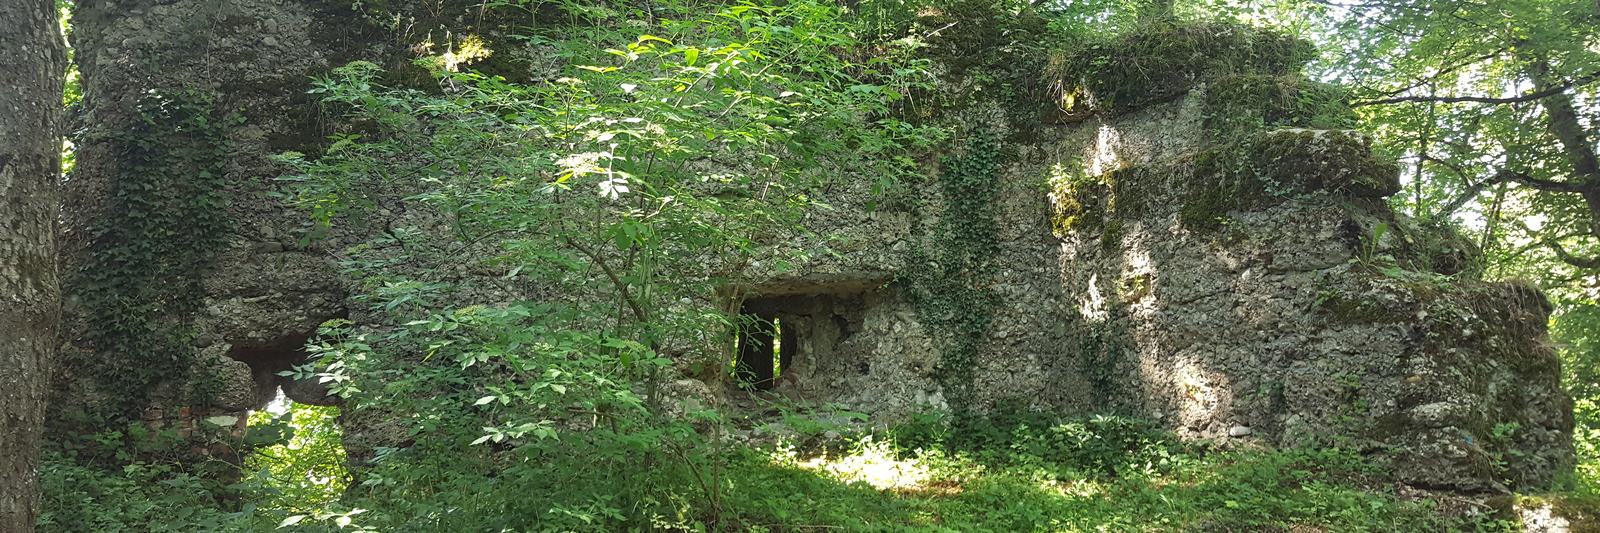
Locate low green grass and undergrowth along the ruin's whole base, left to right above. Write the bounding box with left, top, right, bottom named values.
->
left=40, top=407, right=1517, bottom=533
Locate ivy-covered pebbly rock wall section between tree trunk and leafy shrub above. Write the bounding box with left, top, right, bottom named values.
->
left=51, top=0, right=387, bottom=435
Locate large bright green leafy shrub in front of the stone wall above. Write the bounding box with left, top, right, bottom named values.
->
left=259, top=3, right=939, bottom=531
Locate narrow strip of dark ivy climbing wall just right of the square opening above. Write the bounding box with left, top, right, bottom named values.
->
left=898, top=133, right=1000, bottom=415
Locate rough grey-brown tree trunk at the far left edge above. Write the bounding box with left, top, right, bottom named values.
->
left=0, top=0, right=67, bottom=524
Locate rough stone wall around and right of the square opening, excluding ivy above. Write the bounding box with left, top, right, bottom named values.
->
left=736, top=88, right=1573, bottom=491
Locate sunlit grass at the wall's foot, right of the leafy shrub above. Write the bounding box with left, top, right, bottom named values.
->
left=697, top=409, right=1514, bottom=533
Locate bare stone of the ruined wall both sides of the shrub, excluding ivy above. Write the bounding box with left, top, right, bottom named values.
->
left=54, top=0, right=1573, bottom=491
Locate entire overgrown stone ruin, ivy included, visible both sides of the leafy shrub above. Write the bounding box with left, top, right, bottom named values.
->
left=54, top=0, right=1574, bottom=505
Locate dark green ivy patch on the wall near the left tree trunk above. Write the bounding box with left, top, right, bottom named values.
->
left=70, top=88, right=236, bottom=418
